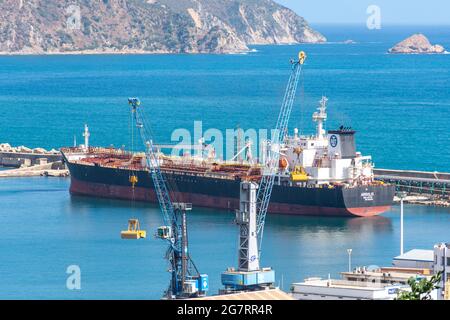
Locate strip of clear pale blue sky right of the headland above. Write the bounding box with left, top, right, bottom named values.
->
left=275, top=0, right=450, bottom=25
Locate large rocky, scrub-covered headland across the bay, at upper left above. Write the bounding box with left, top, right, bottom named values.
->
left=0, top=0, right=326, bottom=54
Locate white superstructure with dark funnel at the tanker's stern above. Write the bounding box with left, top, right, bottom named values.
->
left=280, top=97, right=374, bottom=186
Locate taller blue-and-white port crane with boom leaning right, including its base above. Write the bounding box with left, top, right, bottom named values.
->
left=221, top=51, right=306, bottom=293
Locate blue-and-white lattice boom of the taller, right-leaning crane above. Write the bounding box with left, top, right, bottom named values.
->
left=256, top=51, right=306, bottom=255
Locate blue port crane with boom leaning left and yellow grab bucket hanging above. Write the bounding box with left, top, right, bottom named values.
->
left=122, top=98, right=209, bottom=299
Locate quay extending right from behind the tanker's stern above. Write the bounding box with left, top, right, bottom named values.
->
left=374, top=169, right=450, bottom=207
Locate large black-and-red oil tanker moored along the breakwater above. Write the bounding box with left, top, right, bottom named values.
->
left=61, top=97, right=395, bottom=217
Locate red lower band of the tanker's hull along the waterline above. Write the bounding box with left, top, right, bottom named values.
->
left=70, top=177, right=390, bottom=217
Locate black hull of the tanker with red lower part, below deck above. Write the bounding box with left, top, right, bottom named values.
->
left=66, top=161, right=395, bottom=217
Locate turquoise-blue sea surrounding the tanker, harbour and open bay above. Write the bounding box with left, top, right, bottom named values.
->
left=0, top=25, right=450, bottom=299
